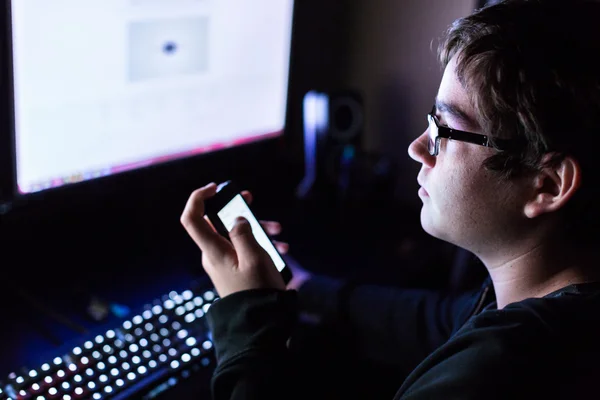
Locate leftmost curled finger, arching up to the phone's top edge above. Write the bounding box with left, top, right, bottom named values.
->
left=181, top=183, right=227, bottom=257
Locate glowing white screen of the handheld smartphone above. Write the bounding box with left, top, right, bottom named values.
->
left=217, top=194, right=285, bottom=272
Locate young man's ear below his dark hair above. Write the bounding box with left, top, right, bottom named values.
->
left=524, top=155, right=581, bottom=218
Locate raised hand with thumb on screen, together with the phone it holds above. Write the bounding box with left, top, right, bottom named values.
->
left=181, top=182, right=291, bottom=297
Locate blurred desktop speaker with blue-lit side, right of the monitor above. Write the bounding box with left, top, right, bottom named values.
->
left=297, top=90, right=365, bottom=198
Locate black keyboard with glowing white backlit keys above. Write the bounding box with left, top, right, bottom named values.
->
left=0, top=289, right=218, bottom=400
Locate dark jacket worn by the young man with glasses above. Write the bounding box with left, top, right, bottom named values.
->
left=207, top=280, right=600, bottom=400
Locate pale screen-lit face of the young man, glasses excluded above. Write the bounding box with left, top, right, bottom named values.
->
left=408, top=59, right=525, bottom=254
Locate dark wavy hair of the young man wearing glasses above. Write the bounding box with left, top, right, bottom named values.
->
left=438, top=0, right=600, bottom=245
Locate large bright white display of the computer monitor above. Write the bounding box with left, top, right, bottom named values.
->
left=12, top=0, right=293, bottom=193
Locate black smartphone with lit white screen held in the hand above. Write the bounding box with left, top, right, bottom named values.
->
left=205, top=181, right=292, bottom=284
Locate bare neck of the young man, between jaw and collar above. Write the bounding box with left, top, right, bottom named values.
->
left=480, top=241, right=600, bottom=309
